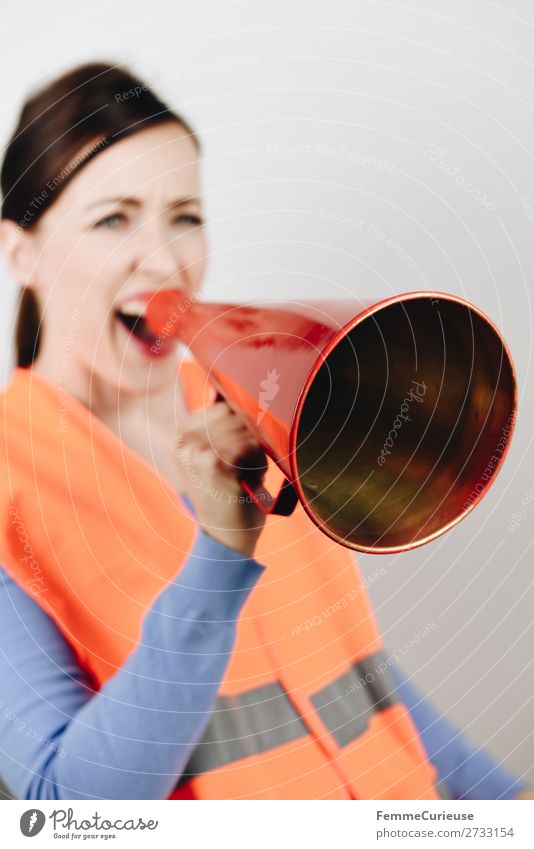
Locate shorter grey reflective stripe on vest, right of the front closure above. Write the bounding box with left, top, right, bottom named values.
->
left=311, top=652, right=398, bottom=746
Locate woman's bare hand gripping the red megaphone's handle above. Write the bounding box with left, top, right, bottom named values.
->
left=175, top=400, right=267, bottom=557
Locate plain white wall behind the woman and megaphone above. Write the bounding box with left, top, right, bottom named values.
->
left=0, top=0, right=534, bottom=781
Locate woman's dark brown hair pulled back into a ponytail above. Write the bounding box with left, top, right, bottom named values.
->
left=0, top=62, right=200, bottom=367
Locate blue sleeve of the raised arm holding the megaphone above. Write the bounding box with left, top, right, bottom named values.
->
left=0, top=529, right=265, bottom=799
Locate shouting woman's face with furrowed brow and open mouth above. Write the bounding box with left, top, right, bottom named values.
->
left=20, top=122, right=207, bottom=393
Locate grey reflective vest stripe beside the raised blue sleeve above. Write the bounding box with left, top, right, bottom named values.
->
left=176, top=681, right=308, bottom=787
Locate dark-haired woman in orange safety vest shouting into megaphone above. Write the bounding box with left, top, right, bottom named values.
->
left=0, top=64, right=521, bottom=799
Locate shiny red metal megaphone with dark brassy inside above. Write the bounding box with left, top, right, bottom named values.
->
left=145, top=290, right=517, bottom=553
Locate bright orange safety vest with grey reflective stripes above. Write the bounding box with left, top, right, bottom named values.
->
left=0, top=362, right=438, bottom=799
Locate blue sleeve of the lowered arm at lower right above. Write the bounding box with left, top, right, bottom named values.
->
left=390, top=666, right=526, bottom=799
